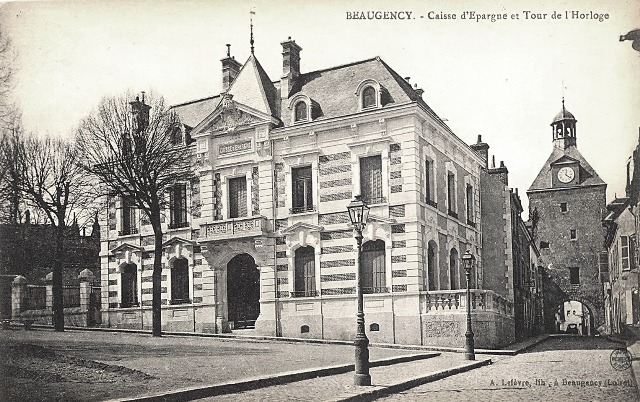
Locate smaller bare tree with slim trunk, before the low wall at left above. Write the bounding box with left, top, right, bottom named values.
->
left=10, top=133, right=93, bottom=331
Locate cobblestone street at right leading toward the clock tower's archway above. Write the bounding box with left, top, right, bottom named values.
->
left=381, top=337, right=638, bottom=402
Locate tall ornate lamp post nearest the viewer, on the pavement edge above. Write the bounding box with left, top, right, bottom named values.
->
left=347, top=195, right=371, bottom=385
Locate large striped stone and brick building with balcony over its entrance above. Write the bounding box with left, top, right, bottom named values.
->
left=102, top=39, right=513, bottom=347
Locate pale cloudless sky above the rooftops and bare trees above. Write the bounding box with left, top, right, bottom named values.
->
left=0, top=0, right=640, bottom=212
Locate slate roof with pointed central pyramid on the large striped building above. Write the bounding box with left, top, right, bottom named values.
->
left=172, top=55, right=430, bottom=128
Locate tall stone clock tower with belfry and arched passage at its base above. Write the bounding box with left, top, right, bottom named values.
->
left=527, top=99, right=607, bottom=334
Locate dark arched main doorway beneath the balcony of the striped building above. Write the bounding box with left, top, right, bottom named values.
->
left=227, top=254, right=260, bottom=328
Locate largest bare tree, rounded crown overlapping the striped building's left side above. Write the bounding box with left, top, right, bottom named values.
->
left=77, top=93, right=192, bottom=336
